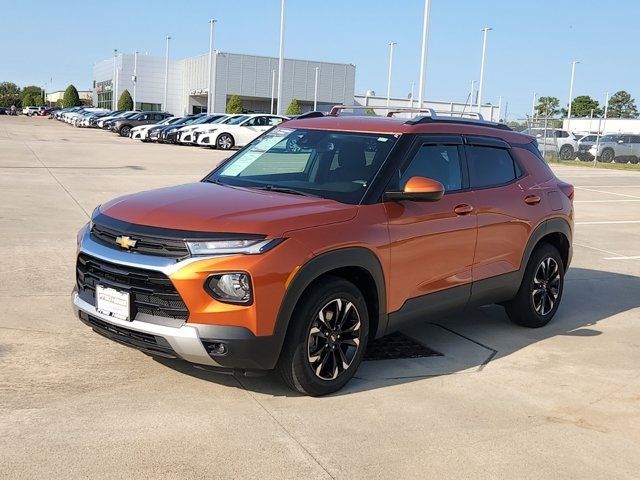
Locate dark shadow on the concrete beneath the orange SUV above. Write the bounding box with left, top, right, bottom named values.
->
left=156, top=268, right=640, bottom=396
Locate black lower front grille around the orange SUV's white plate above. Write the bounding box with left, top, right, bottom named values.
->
left=76, top=253, right=189, bottom=320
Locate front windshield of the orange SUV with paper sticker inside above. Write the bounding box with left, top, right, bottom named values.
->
left=205, top=128, right=396, bottom=204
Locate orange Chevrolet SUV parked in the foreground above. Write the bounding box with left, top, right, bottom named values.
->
left=72, top=107, right=573, bottom=395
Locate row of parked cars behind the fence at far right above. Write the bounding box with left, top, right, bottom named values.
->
left=522, top=128, right=640, bottom=164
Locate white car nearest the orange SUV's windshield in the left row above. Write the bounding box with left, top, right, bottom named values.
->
left=196, top=113, right=289, bottom=150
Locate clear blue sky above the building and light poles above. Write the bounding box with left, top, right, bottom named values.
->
left=0, top=0, right=640, bottom=119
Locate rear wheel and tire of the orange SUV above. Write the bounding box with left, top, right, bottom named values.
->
left=505, top=243, right=564, bottom=328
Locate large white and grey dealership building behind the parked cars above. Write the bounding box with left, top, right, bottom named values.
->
left=93, top=51, right=356, bottom=115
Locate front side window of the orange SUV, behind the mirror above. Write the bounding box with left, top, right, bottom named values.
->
left=399, top=144, right=462, bottom=192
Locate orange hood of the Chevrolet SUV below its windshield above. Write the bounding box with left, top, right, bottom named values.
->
left=99, top=182, right=358, bottom=238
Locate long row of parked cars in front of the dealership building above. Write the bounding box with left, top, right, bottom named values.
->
left=54, top=107, right=289, bottom=150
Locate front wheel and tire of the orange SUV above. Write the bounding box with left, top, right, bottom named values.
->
left=276, top=276, right=369, bottom=396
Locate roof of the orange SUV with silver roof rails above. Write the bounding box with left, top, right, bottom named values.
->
left=286, top=115, right=533, bottom=143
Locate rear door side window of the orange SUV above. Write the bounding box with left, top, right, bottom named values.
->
left=466, top=145, right=517, bottom=188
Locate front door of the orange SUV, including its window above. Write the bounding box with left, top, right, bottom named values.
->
left=385, top=135, right=477, bottom=326
